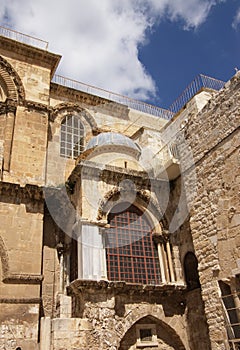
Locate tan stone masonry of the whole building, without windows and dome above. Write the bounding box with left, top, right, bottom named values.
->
left=0, top=33, right=240, bottom=350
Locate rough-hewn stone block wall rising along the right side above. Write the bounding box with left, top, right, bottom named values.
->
left=174, top=73, right=240, bottom=350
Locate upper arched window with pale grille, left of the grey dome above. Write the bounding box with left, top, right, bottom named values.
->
left=60, top=115, right=84, bottom=159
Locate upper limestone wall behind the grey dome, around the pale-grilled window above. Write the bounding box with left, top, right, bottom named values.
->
left=46, top=84, right=167, bottom=186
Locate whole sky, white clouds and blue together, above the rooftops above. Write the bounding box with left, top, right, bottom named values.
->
left=0, top=0, right=240, bottom=108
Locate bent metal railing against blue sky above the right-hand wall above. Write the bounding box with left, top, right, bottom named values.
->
left=169, top=74, right=225, bottom=114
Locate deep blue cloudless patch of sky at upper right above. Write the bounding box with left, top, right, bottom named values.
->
left=139, top=1, right=240, bottom=107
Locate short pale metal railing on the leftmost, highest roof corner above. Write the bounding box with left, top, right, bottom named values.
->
left=0, top=26, right=48, bottom=50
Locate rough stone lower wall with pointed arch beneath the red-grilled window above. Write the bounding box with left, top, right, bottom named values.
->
left=46, top=281, right=188, bottom=350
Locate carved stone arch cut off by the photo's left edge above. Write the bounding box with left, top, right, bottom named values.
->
left=0, top=56, right=25, bottom=104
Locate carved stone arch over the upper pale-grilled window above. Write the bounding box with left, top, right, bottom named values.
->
left=51, top=103, right=98, bottom=134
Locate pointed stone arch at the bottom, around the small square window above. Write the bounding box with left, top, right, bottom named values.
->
left=118, top=314, right=186, bottom=350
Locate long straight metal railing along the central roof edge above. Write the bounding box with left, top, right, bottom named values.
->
left=52, top=74, right=173, bottom=120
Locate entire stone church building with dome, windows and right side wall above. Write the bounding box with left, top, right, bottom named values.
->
left=0, top=29, right=240, bottom=350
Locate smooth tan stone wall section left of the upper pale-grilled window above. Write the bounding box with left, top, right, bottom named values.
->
left=3, top=107, right=48, bottom=185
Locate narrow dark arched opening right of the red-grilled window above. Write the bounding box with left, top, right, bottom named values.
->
left=184, top=252, right=200, bottom=289
